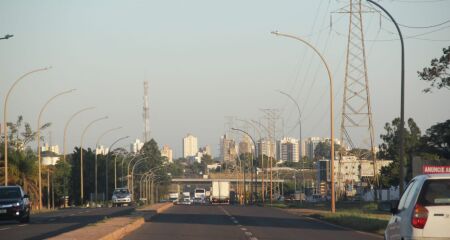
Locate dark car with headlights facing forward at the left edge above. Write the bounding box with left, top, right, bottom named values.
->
left=0, top=186, right=30, bottom=223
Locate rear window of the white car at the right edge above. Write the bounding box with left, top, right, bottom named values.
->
left=419, top=179, right=450, bottom=206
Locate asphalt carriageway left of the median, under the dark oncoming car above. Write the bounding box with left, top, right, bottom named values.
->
left=0, top=207, right=133, bottom=240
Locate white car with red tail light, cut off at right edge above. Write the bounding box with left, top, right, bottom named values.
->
left=384, top=174, right=450, bottom=240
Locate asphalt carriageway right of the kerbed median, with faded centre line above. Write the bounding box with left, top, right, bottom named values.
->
left=125, top=205, right=382, bottom=240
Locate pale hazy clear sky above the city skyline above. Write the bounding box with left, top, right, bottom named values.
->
left=0, top=0, right=450, bottom=157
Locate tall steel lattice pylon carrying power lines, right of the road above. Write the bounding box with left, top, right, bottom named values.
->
left=340, top=0, right=376, bottom=163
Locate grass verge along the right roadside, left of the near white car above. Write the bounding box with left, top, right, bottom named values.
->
left=271, top=201, right=391, bottom=234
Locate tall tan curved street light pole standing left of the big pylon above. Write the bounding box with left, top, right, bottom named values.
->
left=272, top=31, right=336, bottom=213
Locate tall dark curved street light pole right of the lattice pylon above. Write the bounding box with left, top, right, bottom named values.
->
left=367, top=0, right=405, bottom=195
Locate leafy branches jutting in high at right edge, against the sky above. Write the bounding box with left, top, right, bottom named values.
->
left=417, top=46, right=450, bottom=93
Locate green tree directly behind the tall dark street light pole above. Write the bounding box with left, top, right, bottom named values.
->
left=378, top=118, right=421, bottom=187
